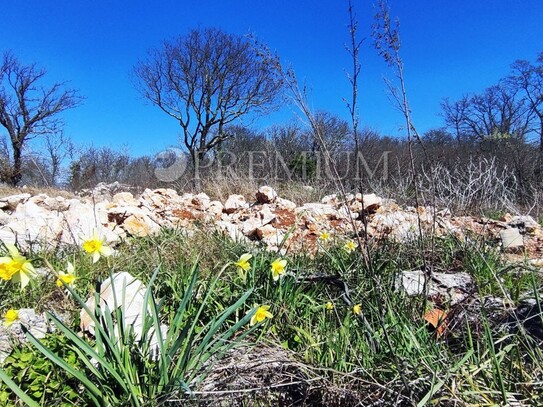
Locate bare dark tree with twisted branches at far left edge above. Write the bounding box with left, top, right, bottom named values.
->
left=0, top=52, right=81, bottom=186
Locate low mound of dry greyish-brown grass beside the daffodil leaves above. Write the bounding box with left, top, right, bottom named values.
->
left=177, top=343, right=379, bottom=407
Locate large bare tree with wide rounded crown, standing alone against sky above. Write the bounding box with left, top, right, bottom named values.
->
left=134, top=28, right=282, bottom=183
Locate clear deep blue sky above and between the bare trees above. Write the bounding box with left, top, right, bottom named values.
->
left=0, top=0, right=543, bottom=155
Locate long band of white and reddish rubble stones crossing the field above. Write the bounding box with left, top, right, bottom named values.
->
left=0, top=185, right=543, bottom=265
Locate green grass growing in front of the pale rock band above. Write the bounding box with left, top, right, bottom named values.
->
left=0, top=230, right=543, bottom=406
